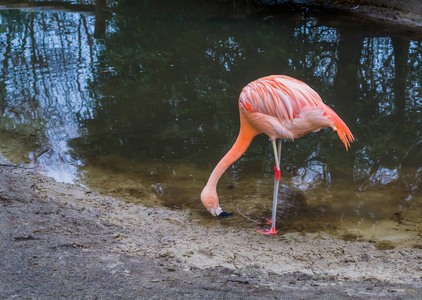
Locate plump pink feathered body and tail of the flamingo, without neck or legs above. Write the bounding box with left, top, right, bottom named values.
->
left=239, top=75, right=354, bottom=149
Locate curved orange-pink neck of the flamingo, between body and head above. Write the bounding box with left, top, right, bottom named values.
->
left=205, top=122, right=259, bottom=190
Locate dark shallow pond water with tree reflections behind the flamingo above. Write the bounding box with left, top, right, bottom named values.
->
left=0, top=1, right=422, bottom=249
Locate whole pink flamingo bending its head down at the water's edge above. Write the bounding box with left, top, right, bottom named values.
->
left=201, top=75, right=354, bottom=234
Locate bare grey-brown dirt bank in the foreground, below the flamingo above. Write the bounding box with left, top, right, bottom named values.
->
left=0, top=166, right=422, bottom=299
